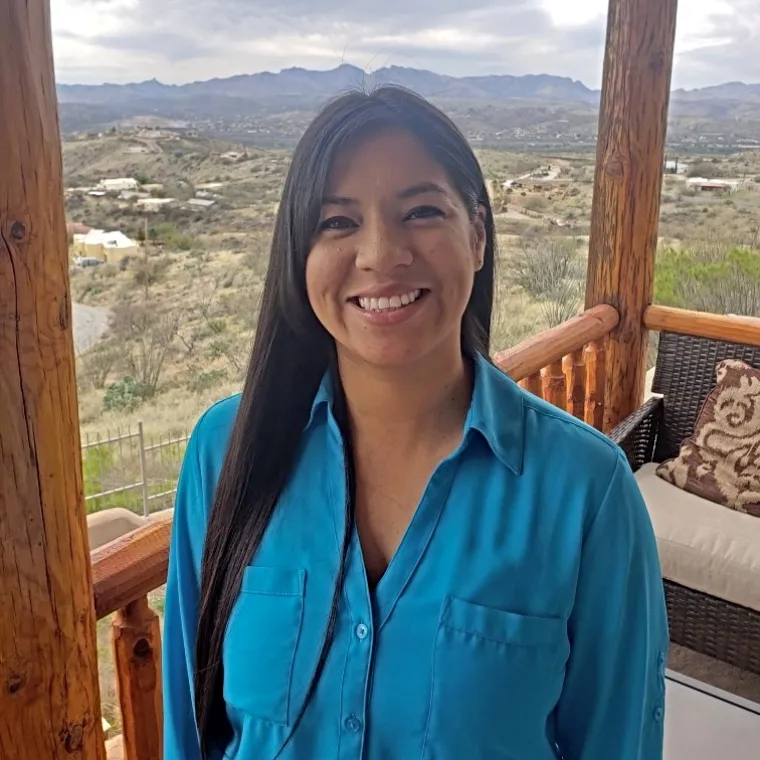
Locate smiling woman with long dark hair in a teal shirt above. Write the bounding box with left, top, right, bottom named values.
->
left=164, top=87, right=668, bottom=760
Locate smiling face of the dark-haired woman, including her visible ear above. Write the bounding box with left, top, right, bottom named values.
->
left=306, top=130, right=485, bottom=367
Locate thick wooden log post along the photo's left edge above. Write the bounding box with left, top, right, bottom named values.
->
left=0, top=0, right=105, bottom=760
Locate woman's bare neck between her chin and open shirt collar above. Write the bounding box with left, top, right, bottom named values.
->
left=338, top=346, right=473, bottom=450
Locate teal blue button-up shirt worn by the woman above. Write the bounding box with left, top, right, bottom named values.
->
left=163, top=358, right=668, bottom=760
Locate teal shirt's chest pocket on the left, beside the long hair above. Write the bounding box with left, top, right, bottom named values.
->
left=222, top=566, right=306, bottom=726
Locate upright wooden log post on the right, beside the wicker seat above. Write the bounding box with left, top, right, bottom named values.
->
left=586, top=0, right=678, bottom=431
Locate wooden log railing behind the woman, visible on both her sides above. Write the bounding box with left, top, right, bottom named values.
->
left=91, top=306, right=618, bottom=760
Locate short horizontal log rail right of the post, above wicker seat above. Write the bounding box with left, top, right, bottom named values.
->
left=644, top=306, right=760, bottom=346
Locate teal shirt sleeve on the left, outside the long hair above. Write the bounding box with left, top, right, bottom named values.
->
left=163, top=428, right=206, bottom=760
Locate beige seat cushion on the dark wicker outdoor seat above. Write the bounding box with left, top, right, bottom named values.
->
left=636, top=464, right=760, bottom=612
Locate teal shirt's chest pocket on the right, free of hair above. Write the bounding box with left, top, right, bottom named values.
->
left=423, top=597, right=569, bottom=760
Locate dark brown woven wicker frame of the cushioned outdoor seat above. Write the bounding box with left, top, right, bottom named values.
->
left=610, top=332, right=760, bottom=673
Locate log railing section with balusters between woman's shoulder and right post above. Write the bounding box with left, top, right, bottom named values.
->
left=494, top=305, right=619, bottom=430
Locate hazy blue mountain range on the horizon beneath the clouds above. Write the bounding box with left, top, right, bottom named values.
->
left=58, top=64, right=760, bottom=148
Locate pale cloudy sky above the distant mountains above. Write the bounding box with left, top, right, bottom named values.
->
left=51, top=0, right=760, bottom=88
